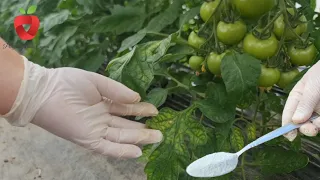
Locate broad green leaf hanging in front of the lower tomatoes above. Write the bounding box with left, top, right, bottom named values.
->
left=221, top=52, right=261, bottom=101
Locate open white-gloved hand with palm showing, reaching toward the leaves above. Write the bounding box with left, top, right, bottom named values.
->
left=3, top=57, right=162, bottom=158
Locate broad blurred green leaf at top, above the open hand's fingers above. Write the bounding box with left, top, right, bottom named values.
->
left=91, top=5, right=146, bottom=35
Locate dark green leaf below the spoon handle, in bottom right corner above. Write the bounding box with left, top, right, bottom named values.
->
left=256, top=147, right=309, bottom=175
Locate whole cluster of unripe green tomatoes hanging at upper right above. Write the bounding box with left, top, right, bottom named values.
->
left=188, top=0, right=318, bottom=88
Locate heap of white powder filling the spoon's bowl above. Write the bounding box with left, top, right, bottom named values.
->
left=187, top=152, right=238, bottom=177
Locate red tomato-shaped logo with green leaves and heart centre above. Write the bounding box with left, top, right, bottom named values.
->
left=14, top=6, right=40, bottom=40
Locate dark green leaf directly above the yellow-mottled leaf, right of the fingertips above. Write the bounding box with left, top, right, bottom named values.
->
left=196, top=83, right=236, bottom=123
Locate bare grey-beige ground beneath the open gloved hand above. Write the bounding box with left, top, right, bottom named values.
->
left=0, top=119, right=146, bottom=180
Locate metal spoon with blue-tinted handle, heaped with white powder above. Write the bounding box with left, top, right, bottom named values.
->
left=186, top=113, right=319, bottom=177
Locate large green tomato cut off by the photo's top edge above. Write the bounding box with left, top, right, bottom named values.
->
left=232, top=0, right=277, bottom=19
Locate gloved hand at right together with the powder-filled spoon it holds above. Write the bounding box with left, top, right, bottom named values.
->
left=186, top=62, right=320, bottom=177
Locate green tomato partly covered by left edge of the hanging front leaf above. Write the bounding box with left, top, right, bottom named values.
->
left=207, top=51, right=227, bottom=75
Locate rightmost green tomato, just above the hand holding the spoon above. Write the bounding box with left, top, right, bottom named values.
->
left=288, top=44, right=317, bottom=66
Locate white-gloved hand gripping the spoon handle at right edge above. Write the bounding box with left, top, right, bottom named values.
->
left=282, top=62, right=320, bottom=141
